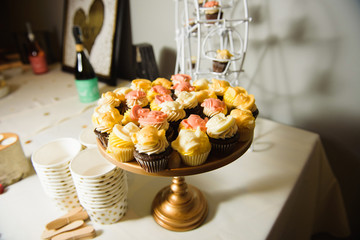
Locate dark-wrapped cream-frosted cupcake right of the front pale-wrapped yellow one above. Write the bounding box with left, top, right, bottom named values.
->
left=206, top=113, right=239, bottom=154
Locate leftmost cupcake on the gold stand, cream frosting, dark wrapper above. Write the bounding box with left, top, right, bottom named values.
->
left=91, top=105, right=123, bottom=148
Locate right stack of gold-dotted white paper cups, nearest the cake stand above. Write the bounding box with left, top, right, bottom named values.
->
left=70, top=148, right=128, bottom=224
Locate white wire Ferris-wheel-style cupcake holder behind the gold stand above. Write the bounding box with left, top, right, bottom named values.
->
left=175, top=0, right=251, bottom=85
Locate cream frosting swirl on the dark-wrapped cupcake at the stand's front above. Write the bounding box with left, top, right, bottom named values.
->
left=131, top=126, right=169, bottom=155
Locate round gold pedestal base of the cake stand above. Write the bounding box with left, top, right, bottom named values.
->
left=152, top=177, right=208, bottom=232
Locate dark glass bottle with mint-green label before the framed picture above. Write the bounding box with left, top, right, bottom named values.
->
left=73, top=26, right=100, bottom=103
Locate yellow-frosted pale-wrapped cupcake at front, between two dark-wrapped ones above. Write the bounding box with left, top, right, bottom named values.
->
left=171, top=127, right=211, bottom=166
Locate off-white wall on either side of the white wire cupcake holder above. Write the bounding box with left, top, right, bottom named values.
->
left=130, top=0, right=360, bottom=236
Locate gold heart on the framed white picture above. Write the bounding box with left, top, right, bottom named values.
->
left=73, top=0, right=104, bottom=54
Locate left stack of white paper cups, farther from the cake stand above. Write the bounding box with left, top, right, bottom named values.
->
left=31, top=138, right=81, bottom=211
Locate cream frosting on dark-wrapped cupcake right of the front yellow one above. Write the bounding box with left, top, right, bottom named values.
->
left=206, top=113, right=238, bottom=139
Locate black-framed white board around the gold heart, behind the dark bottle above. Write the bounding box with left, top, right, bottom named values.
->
left=61, top=0, right=125, bottom=86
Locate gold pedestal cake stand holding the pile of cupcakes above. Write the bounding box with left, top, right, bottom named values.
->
left=97, top=138, right=252, bottom=231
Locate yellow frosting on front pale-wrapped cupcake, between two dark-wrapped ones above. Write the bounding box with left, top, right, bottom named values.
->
left=171, top=127, right=211, bottom=156
